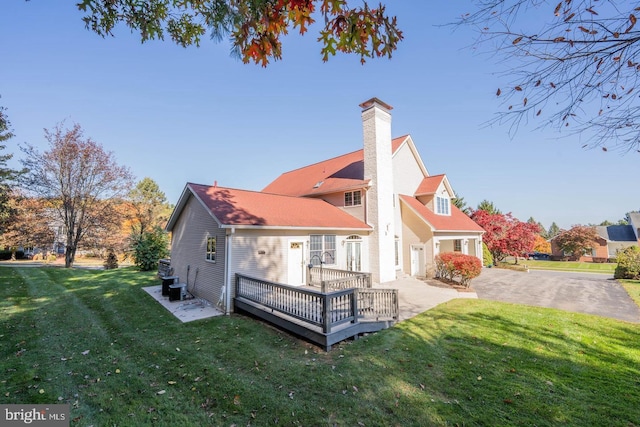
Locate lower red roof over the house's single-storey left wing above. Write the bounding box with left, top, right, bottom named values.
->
left=167, top=183, right=371, bottom=230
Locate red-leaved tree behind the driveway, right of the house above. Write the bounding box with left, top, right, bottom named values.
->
left=471, top=209, right=540, bottom=263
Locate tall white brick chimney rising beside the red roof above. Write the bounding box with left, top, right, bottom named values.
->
left=360, top=98, right=396, bottom=283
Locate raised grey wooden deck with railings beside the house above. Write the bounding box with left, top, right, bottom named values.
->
left=234, top=274, right=399, bottom=351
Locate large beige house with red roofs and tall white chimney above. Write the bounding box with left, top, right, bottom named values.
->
left=167, top=98, right=484, bottom=311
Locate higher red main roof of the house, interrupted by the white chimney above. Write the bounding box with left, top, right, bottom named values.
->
left=262, top=135, right=408, bottom=196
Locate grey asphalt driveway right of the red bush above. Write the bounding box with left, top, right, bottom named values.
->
left=471, top=268, right=640, bottom=323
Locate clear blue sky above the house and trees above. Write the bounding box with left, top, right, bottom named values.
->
left=0, top=0, right=640, bottom=228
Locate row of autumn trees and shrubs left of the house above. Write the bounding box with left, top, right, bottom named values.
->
left=0, top=108, right=172, bottom=270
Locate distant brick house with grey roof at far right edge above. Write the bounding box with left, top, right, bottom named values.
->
left=551, top=212, right=640, bottom=262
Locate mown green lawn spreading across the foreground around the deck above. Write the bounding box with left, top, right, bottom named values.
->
left=0, top=267, right=640, bottom=427
